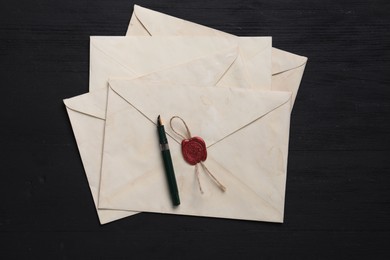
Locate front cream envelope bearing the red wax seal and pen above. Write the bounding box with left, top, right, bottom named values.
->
left=99, top=80, right=291, bottom=222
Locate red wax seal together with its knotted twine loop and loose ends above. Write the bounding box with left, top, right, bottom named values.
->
left=169, top=116, right=226, bottom=194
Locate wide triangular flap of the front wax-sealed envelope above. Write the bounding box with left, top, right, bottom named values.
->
left=110, top=80, right=291, bottom=146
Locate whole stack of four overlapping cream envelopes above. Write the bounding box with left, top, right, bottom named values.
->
left=64, top=6, right=307, bottom=224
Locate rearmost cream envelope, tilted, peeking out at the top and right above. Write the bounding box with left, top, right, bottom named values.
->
left=127, top=5, right=307, bottom=106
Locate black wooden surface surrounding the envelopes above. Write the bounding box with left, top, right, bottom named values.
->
left=0, top=0, right=390, bottom=259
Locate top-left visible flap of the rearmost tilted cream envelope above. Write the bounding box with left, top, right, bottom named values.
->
left=134, top=5, right=232, bottom=37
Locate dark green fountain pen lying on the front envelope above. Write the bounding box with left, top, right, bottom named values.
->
left=157, top=116, right=180, bottom=206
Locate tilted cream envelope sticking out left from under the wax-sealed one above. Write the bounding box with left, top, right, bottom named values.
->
left=64, top=37, right=271, bottom=224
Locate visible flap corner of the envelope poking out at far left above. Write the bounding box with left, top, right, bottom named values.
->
left=64, top=88, right=107, bottom=119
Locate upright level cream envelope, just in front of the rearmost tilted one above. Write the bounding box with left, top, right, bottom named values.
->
left=89, top=36, right=272, bottom=91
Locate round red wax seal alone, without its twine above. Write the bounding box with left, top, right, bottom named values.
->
left=181, top=136, right=207, bottom=165
